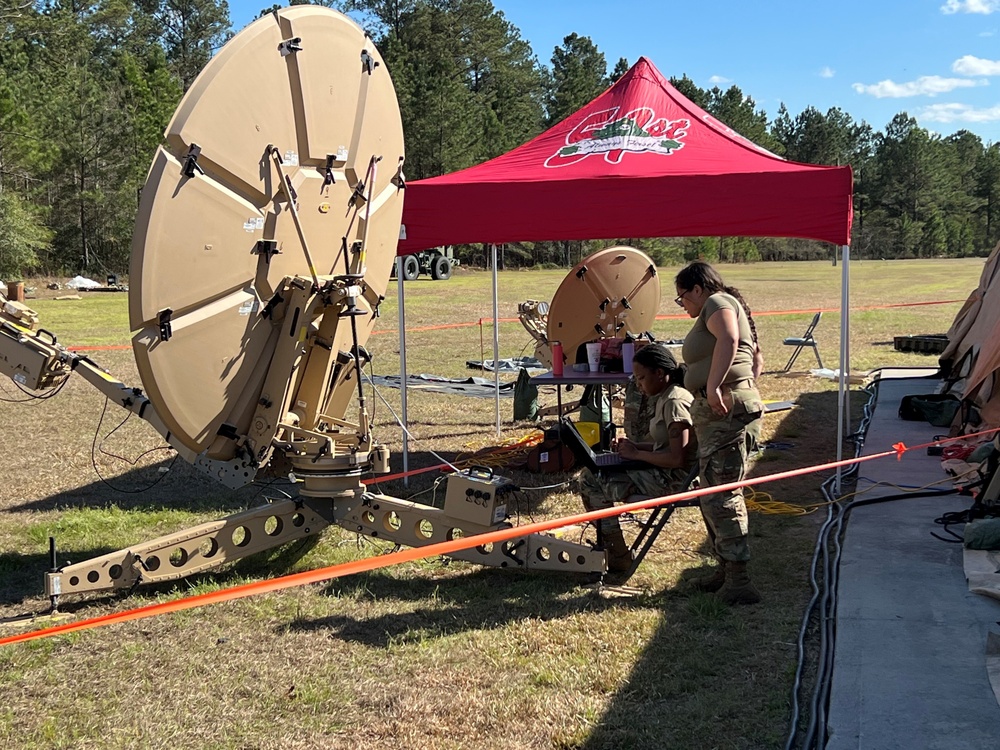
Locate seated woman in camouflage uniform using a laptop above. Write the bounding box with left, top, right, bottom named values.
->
left=581, top=344, right=698, bottom=573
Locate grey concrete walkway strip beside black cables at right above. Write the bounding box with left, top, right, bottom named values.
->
left=826, top=370, right=1000, bottom=750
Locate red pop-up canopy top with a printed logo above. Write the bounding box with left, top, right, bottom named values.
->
left=398, top=57, right=853, bottom=255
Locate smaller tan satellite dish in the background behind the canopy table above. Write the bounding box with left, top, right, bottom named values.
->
left=546, top=246, right=660, bottom=364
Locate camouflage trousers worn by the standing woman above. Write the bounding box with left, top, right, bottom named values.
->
left=691, top=388, right=764, bottom=562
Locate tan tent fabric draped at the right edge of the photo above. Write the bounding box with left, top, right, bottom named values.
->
left=941, top=244, right=1000, bottom=428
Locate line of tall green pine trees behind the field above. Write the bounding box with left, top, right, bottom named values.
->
left=0, top=0, right=1000, bottom=278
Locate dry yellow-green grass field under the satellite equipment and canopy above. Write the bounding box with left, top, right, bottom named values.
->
left=0, top=259, right=983, bottom=750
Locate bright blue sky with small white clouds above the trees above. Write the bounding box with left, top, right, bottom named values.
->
left=229, top=0, right=1000, bottom=143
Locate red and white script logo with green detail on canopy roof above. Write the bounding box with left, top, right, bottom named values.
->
left=545, top=107, right=691, bottom=167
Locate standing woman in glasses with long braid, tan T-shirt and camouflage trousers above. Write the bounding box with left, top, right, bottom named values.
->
left=674, top=261, right=764, bottom=604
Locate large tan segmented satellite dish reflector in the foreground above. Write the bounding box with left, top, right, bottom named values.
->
left=129, top=5, right=403, bottom=460
